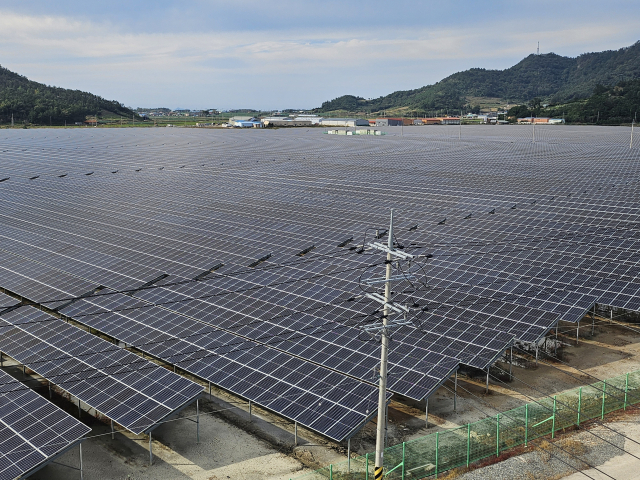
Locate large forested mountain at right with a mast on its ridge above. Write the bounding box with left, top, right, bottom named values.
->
left=316, top=42, right=640, bottom=112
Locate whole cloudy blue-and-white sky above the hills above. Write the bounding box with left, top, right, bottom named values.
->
left=0, top=0, right=640, bottom=109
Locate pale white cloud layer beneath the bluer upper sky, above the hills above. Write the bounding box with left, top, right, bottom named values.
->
left=0, top=10, right=637, bottom=108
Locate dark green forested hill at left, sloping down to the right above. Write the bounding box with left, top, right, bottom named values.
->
left=0, top=66, right=137, bottom=125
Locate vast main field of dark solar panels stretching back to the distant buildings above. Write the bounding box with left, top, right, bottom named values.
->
left=0, top=126, right=640, bottom=439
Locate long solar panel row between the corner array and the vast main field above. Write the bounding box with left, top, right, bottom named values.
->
left=0, top=306, right=202, bottom=434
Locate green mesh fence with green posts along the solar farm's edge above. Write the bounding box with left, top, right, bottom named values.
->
left=296, top=371, right=640, bottom=480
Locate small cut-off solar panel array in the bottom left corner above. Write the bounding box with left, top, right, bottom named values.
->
left=0, top=370, right=91, bottom=480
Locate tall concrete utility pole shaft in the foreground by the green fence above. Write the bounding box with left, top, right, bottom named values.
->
left=374, top=209, right=393, bottom=480
